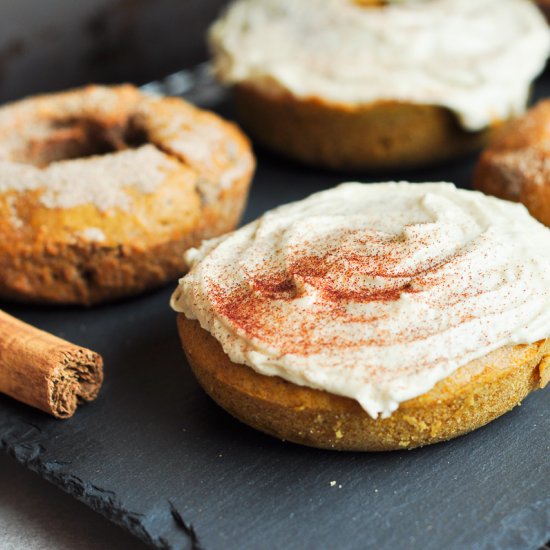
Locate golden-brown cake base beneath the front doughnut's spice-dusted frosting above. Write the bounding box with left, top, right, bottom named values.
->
left=178, top=314, right=550, bottom=451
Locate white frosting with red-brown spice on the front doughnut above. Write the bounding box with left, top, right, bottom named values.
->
left=171, top=182, right=550, bottom=417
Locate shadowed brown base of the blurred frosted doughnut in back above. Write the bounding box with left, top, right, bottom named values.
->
left=234, top=85, right=489, bottom=171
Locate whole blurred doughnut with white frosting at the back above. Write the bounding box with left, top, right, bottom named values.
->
left=210, top=0, right=550, bottom=170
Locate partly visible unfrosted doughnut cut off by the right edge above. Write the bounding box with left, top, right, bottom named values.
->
left=474, top=100, right=550, bottom=226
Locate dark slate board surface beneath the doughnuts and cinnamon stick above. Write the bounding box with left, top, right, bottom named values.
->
left=0, top=76, right=550, bottom=550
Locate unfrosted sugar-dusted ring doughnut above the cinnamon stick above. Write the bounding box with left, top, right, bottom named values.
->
left=0, top=85, right=254, bottom=304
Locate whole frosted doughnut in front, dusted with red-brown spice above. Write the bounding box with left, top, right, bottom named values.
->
left=172, top=183, right=550, bottom=451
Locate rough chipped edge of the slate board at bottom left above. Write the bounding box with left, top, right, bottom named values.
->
left=0, top=421, right=195, bottom=550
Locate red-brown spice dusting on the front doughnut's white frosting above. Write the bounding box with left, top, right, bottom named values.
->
left=210, top=225, right=494, bottom=362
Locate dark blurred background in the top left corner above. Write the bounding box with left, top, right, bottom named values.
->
left=0, top=0, right=226, bottom=102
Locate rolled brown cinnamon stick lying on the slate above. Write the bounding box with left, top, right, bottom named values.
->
left=0, top=311, right=103, bottom=418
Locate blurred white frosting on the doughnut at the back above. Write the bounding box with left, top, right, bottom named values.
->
left=210, top=0, right=550, bottom=130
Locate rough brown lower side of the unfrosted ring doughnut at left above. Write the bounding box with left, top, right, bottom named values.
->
left=0, top=184, right=250, bottom=305
